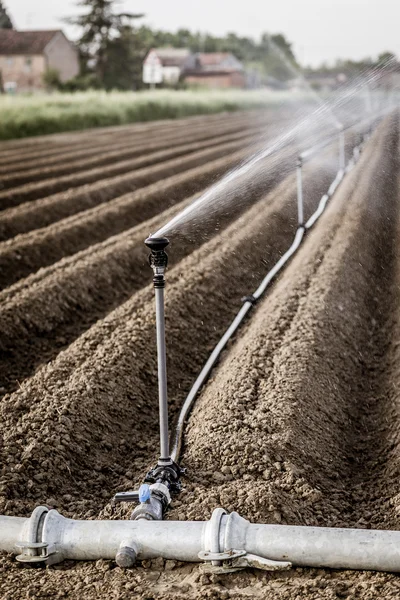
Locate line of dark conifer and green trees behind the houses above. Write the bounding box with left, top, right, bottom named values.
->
left=61, top=0, right=297, bottom=90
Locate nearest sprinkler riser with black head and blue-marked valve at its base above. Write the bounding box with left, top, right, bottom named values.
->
left=114, top=237, right=183, bottom=520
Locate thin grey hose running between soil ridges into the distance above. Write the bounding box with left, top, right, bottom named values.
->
left=171, top=123, right=376, bottom=462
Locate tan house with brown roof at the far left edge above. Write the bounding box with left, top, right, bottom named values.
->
left=0, top=29, right=79, bottom=92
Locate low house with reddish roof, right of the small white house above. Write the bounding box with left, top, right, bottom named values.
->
left=184, top=52, right=247, bottom=88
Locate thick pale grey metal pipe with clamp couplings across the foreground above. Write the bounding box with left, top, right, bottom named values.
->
left=5, top=506, right=400, bottom=573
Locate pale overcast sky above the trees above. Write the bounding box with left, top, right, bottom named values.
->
left=7, top=0, right=400, bottom=65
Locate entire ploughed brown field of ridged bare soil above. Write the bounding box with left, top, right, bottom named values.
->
left=0, top=110, right=400, bottom=600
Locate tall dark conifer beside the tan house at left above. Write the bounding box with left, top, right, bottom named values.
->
left=66, top=0, right=143, bottom=83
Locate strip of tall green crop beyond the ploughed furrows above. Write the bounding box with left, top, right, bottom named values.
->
left=0, top=90, right=298, bottom=140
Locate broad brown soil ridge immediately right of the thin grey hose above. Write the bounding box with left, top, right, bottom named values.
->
left=180, top=113, right=398, bottom=526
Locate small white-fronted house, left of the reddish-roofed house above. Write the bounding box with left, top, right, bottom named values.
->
left=143, top=48, right=191, bottom=85
